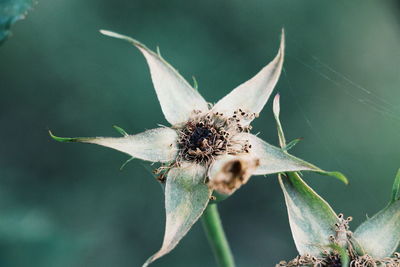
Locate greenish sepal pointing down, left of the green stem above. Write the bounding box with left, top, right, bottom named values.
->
left=143, top=163, right=211, bottom=266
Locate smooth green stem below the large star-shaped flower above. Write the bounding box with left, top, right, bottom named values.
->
left=201, top=204, right=235, bottom=267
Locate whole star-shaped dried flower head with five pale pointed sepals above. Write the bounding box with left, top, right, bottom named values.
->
left=52, top=30, right=345, bottom=266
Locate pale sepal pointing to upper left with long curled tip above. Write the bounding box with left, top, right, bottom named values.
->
left=100, top=30, right=208, bottom=125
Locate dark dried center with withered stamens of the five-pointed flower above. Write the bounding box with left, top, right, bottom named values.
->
left=177, top=112, right=250, bottom=165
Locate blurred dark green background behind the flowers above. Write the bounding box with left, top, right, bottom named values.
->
left=0, top=0, right=400, bottom=267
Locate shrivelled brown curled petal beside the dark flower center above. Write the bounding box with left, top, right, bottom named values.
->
left=208, top=154, right=259, bottom=195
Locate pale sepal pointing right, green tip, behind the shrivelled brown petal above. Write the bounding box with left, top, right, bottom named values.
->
left=235, top=133, right=347, bottom=183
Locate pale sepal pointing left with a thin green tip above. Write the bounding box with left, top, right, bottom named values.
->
left=50, top=127, right=178, bottom=162
